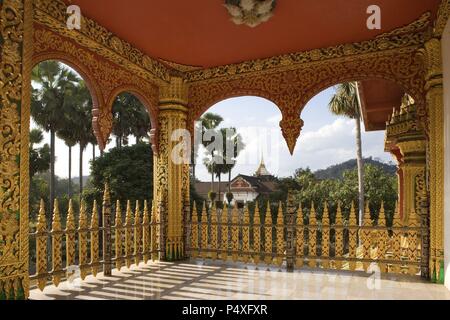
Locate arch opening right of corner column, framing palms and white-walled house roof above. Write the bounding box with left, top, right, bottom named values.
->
left=191, top=96, right=286, bottom=206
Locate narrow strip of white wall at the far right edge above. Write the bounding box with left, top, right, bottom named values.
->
left=442, top=21, right=450, bottom=290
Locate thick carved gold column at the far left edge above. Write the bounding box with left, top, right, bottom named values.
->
left=0, top=0, right=33, bottom=299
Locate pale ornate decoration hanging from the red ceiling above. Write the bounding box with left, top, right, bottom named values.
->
left=224, top=0, right=276, bottom=28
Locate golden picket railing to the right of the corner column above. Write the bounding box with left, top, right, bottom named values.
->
left=188, top=199, right=426, bottom=275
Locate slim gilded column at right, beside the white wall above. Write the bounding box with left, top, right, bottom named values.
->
left=422, top=38, right=444, bottom=283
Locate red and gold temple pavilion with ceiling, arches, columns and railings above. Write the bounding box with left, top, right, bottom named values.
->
left=0, top=0, right=450, bottom=299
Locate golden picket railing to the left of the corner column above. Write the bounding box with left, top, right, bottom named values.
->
left=30, top=186, right=161, bottom=290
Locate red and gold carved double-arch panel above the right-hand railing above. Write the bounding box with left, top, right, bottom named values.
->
left=189, top=47, right=426, bottom=151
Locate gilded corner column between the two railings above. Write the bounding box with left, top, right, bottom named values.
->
left=154, top=77, right=190, bottom=260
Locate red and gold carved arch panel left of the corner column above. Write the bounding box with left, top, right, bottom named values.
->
left=33, top=26, right=159, bottom=148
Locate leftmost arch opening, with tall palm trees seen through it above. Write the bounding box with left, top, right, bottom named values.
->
left=28, top=59, right=99, bottom=274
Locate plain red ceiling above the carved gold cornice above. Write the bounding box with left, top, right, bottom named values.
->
left=66, top=0, right=440, bottom=67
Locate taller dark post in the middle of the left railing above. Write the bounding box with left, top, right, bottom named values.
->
left=102, top=184, right=112, bottom=276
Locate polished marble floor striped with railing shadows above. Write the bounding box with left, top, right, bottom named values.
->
left=30, top=261, right=450, bottom=300
